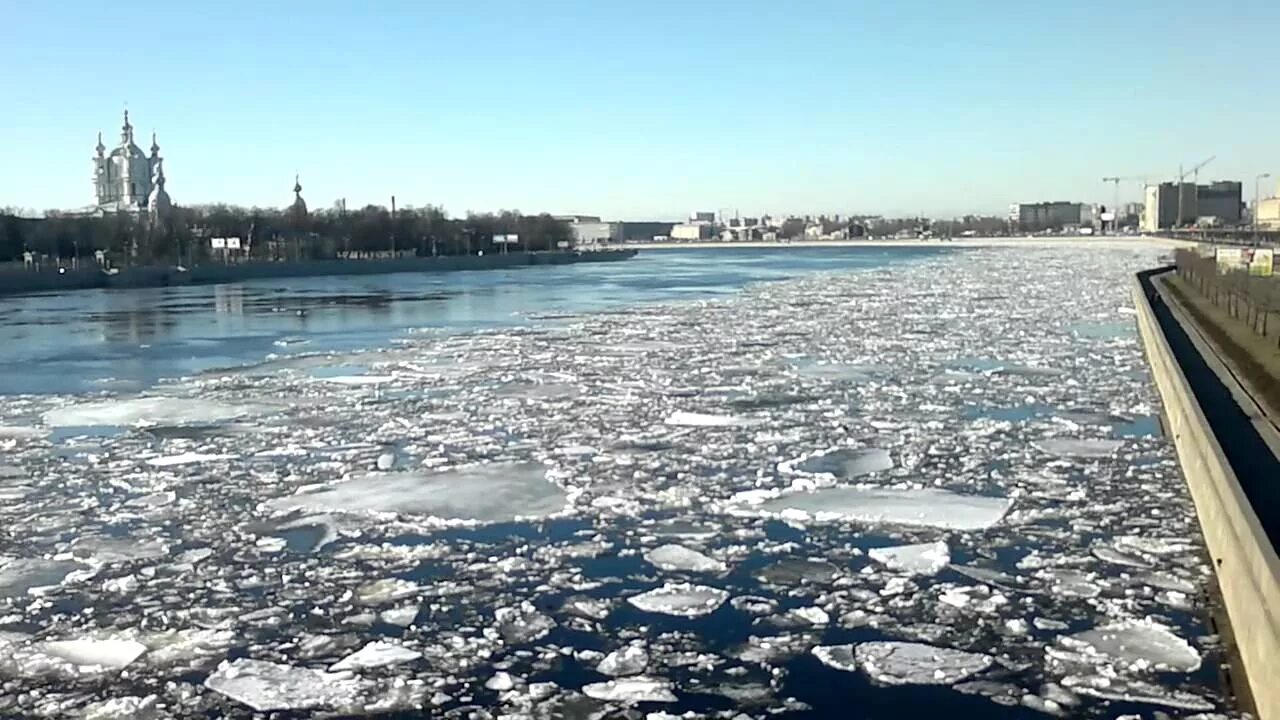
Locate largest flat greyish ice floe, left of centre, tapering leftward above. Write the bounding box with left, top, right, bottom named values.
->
left=265, top=462, right=568, bottom=523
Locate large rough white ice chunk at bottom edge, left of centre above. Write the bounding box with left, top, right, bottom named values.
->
left=205, top=657, right=365, bottom=712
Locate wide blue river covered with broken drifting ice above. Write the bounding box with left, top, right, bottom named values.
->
left=0, top=246, right=1224, bottom=720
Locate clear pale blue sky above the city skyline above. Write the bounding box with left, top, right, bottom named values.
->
left=0, top=0, right=1280, bottom=219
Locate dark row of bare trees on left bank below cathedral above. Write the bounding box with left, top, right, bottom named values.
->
left=0, top=205, right=573, bottom=265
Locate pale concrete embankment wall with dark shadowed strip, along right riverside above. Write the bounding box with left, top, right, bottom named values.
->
left=1133, top=269, right=1280, bottom=720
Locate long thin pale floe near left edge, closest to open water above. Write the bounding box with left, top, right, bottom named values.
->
left=44, top=397, right=262, bottom=428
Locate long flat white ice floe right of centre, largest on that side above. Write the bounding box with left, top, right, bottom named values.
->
left=760, top=487, right=1014, bottom=530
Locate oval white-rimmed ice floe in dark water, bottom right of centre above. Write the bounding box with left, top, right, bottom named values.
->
left=813, top=642, right=993, bottom=685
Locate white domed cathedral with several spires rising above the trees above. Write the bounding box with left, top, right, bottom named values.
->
left=91, top=110, right=172, bottom=222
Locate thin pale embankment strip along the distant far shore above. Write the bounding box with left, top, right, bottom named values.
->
left=617, top=236, right=1196, bottom=250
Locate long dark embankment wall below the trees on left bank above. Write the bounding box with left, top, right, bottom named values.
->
left=0, top=250, right=636, bottom=295
